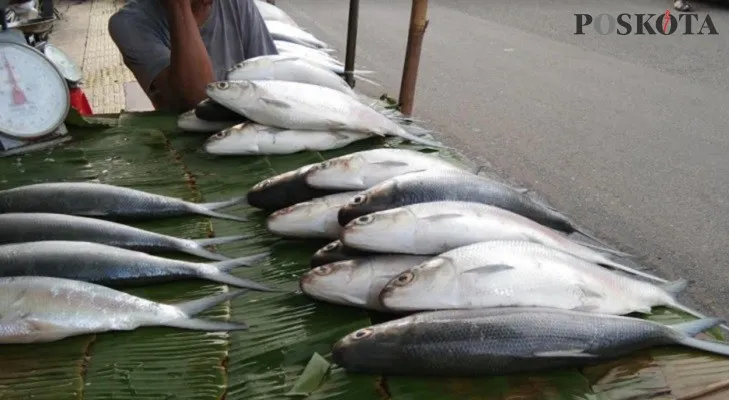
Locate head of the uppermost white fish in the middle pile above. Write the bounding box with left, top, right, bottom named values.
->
left=306, top=154, right=367, bottom=190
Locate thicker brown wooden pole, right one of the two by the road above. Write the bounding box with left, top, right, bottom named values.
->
left=399, top=0, right=428, bottom=116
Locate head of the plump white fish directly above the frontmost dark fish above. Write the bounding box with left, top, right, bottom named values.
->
left=380, top=256, right=458, bottom=311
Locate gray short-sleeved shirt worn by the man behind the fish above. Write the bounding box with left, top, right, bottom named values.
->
left=109, top=0, right=278, bottom=98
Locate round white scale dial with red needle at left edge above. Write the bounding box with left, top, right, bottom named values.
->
left=0, top=42, right=71, bottom=139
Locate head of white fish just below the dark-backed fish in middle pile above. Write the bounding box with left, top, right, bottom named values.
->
left=340, top=207, right=418, bottom=254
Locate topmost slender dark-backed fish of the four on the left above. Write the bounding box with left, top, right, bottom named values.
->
left=0, top=182, right=247, bottom=221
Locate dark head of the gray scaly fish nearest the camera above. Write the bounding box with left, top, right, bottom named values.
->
left=332, top=317, right=413, bottom=372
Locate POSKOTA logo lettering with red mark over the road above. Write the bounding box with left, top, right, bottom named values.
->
left=575, top=10, right=719, bottom=35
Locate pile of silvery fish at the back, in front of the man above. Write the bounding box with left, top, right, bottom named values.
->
left=178, top=3, right=441, bottom=155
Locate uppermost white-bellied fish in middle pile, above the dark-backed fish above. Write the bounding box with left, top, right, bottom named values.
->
left=306, top=148, right=460, bottom=190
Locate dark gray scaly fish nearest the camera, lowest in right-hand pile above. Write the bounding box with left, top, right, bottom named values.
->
left=332, top=307, right=729, bottom=378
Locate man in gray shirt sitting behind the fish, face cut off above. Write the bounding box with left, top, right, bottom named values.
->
left=109, top=0, right=278, bottom=111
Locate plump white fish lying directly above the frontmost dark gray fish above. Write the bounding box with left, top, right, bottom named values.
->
left=380, top=240, right=720, bottom=330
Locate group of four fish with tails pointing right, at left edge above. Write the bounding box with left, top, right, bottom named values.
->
left=0, top=182, right=278, bottom=343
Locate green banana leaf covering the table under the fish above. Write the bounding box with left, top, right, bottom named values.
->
left=0, top=113, right=729, bottom=400
